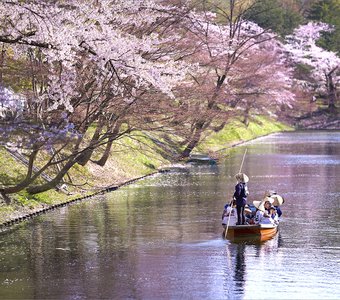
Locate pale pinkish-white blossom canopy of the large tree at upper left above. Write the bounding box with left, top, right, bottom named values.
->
left=0, top=0, right=188, bottom=112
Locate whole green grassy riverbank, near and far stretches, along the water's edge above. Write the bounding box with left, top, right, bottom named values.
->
left=0, top=117, right=292, bottom=226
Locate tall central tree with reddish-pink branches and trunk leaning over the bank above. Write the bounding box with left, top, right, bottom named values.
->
left=168, top=1, right=291, bottom=157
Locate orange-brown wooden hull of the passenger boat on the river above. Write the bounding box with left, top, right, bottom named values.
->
left=223, top=224, right=278, bottom=242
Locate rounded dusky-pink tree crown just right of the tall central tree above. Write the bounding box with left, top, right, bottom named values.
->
left=230, top=40, right=295, bottom=126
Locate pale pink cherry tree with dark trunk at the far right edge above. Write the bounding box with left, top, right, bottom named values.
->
left=285, top=22, right=340, bottom=111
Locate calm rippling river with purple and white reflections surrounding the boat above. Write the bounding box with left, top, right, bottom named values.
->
left=0, top=131, right=340, bottom=299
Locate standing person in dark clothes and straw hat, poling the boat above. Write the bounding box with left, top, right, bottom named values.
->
left=234, top=173, right=249, bottom=225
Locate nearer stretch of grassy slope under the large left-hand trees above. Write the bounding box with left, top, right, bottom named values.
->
left=0, top=138, right=168, bottom=223
